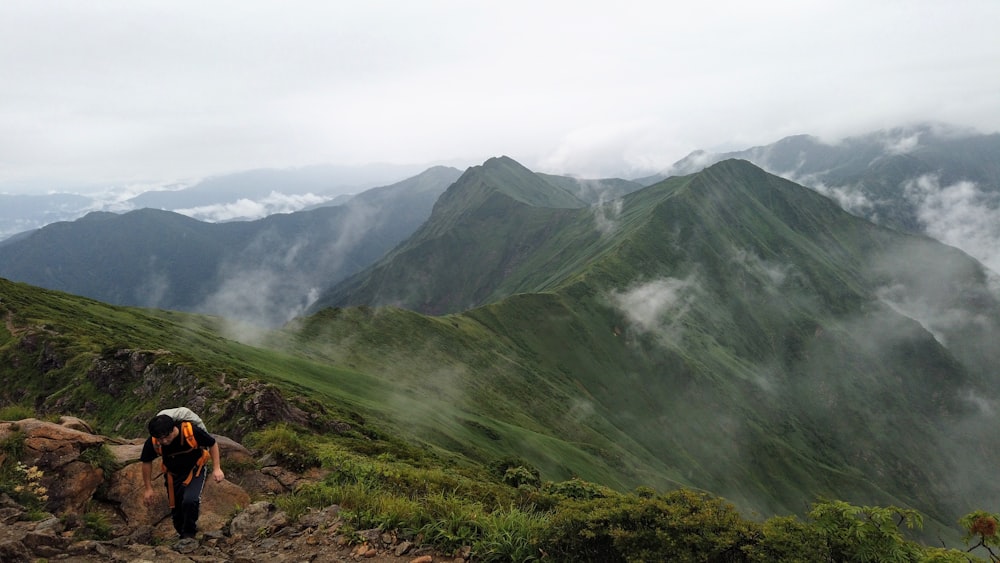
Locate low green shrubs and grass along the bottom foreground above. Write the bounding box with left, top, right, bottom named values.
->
left=246, top=426, right=1000, bottom=563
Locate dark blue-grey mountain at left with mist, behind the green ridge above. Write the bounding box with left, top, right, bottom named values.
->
left=0, top=167, right=460, bottom=326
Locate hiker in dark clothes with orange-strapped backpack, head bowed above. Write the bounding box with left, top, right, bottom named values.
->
left=139, top=414, right=226, bottom=539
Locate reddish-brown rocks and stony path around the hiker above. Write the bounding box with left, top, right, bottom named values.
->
left=0, top=417, right=464, bottom=563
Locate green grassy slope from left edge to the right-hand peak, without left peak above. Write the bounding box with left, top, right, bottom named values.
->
left=0, top=159, right=997, bottom=536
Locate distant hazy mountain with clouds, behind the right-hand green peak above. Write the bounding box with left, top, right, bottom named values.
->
left=637, top=124, right=1000, bottom=238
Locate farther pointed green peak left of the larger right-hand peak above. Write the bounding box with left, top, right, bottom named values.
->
left=312, top=157, right=594, bottom=313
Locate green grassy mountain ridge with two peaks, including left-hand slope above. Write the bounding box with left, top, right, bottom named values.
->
left=0, top=154, right=1000, bottom=540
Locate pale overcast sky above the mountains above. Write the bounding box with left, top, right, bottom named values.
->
left=0, top=0, right=1000, bottom=193
